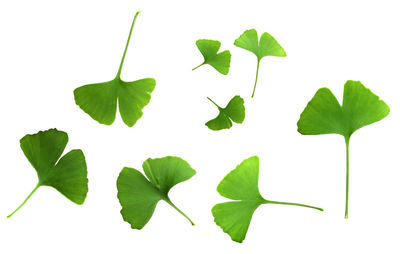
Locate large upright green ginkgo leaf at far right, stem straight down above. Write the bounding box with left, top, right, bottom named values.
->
left=297, top=80, right=390, bottom=218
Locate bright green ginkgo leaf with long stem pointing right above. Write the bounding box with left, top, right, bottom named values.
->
left=212, top=156, right=323, bottom=243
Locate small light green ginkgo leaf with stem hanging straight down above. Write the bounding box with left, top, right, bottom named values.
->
left=234, top=29, right=286, bottom=97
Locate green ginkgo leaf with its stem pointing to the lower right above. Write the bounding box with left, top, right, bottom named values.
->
left=117, top=156, right=196, bottom=229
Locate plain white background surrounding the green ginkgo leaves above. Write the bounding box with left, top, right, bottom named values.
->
left=0, top=0, right=400, bottom=254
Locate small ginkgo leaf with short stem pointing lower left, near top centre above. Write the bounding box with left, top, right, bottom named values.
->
left=193, top=40, right=231, bottom=75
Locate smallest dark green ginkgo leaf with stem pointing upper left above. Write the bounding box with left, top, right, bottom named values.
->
left=206, top=95, right=245, bottom=131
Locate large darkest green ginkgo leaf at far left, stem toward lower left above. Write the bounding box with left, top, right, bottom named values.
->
left=7, top=129, right=88, bottom=218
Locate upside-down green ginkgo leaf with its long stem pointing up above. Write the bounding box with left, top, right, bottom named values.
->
left=74, top=12, right=156, bottom=127
